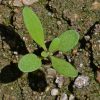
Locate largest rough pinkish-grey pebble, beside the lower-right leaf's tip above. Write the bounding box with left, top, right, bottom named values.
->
left=74, top=75, right=89, bottom=88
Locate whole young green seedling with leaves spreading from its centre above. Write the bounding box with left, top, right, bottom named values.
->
left=18, top=7, right=79, bottom=77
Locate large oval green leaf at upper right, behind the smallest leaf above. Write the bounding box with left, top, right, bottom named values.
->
left=59, top=30, right=79, bottom=52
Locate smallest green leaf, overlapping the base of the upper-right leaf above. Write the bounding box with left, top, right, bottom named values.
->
left=49, top=38, right=60, bottom=52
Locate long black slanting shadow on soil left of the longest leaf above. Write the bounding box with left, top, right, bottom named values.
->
left=0, top=24, right=28, bottom=55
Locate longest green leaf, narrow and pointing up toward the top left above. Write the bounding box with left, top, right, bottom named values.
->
left=23, top=7, right=46, bottom=50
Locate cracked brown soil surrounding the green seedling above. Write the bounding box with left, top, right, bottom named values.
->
left=0, top=0, right=100, bottom=100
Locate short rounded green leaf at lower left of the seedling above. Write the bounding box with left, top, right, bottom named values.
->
left=18, top=54, right=41, bottom=72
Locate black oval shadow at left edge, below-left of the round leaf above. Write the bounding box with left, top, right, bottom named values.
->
left=0, top=62, right=23, bottom=83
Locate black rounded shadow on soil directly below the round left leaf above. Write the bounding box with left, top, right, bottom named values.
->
left=28, top=70, right=47, bottom=92
